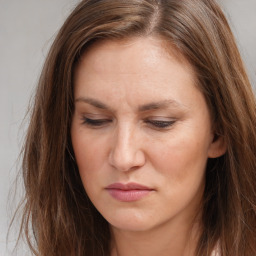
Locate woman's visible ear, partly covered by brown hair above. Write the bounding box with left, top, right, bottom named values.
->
left=208, top=134, right=227, bottom=158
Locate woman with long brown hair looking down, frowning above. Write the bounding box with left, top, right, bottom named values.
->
left=18, top=0, right=256, bottom=256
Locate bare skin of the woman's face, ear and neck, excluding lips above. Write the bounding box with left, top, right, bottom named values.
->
left=71, top=37, right=225, bottom=256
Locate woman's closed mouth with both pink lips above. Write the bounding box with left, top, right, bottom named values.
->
left=106, top=183, right=154, bottom=202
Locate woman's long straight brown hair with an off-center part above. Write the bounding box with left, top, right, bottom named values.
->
left=18, top=0, right=256, bottom=256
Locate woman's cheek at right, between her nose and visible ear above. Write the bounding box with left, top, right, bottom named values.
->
left=149, top=135, right=208, bottom=184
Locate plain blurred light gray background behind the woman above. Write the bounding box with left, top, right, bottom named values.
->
left=0, top=0, right=256, bottom=256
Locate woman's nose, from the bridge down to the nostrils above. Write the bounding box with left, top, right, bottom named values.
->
left=109, top=126, right=145, bottom=171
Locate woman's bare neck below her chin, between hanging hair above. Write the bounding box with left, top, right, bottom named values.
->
left=111, top=216, right=200, bottom=256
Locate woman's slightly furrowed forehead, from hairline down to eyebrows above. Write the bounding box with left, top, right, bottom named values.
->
left=74, top=37, right=204, bottom=112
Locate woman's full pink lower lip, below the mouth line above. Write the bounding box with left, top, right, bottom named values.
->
left=107, top=189, right=152, bottom=202
